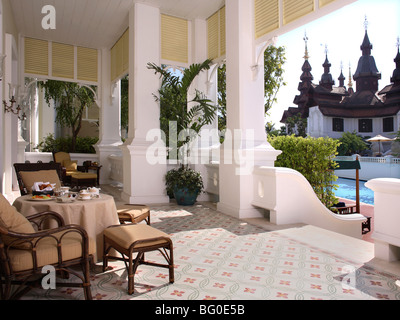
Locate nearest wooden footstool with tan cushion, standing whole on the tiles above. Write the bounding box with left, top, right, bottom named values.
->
left=103, top=223, right=174, bottom=294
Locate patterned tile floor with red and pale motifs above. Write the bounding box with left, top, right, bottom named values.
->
left=23, top=205, right=400, bottom=300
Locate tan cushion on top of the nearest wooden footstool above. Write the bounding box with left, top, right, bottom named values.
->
left=104, top=224, right=170, bottom=250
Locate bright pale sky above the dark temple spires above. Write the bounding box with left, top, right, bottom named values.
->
left=267, top=0, right=400, bottom=129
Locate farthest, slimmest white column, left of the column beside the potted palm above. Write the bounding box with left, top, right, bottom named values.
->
left=95, top=49, right=122, bottom=184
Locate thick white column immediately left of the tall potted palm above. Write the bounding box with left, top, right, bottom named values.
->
left=121, top=3, right=169, bottom=204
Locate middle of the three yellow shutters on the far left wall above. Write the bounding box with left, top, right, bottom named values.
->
left=52, top=42, right=75, bottom=79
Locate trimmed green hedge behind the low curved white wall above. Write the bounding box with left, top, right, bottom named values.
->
left=268, top=135, right=339, bottom=208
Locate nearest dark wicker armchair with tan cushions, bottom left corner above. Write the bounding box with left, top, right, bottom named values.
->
left=0, top=194, right=95, bottom=300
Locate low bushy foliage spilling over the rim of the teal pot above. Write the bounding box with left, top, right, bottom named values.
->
left=165, top=166, right=204, bottom=197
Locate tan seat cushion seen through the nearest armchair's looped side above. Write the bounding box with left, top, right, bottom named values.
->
left=9, top=231, right=96, bottom=272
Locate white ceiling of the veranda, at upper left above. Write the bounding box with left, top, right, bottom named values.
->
left=10, top=0, right=225, bottom=48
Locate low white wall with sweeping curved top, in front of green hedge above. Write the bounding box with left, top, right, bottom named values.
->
left=252, top=167, right=366, bottom=238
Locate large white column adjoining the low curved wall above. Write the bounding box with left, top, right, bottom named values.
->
left=218, top=0, right=280, bottom=218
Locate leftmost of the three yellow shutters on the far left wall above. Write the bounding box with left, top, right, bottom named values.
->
left=25, top=38, right=49, bottom=76
